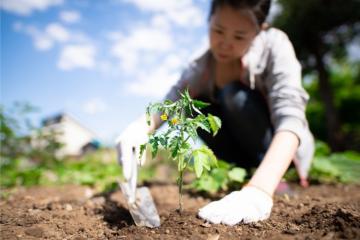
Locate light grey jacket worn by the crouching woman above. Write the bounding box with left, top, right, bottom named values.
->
left=166, top=28, right=314, bottom=179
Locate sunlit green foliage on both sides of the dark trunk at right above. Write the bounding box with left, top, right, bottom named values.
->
left=305, top=60, right=360, bottom=151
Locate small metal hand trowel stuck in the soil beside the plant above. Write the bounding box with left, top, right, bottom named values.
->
left=119, top=148, right=160, bottom=228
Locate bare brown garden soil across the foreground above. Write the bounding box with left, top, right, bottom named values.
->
left=0, top=184, right=360, bottom=240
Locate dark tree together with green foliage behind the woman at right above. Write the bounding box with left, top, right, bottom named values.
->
left=273, top=0, right=360, bottom=151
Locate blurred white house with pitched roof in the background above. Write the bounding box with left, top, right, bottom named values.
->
left=42, top=113, right=100, bottom=156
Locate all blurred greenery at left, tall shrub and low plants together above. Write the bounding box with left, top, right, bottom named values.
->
left=0, top=103, right=154, bottom=191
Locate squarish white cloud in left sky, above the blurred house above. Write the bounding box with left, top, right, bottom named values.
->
left=57, top=44, right=96, bottom=70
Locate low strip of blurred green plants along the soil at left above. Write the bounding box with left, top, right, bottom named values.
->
left=0, top=149, right=154, bottom=191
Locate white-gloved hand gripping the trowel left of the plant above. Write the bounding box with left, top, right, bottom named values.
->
left=116, top=117, right=149, bottom=181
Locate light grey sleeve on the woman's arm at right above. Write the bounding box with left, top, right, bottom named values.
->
left=266, top=29, right=309, bottom=145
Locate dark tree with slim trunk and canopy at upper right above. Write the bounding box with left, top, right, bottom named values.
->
left=273, top=0, right=360, bottom=151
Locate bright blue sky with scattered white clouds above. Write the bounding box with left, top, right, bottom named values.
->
left=0, top=0, right=210, bottom=143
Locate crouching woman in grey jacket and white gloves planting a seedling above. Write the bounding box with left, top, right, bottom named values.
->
left=117, top=0, right=314, bottom=225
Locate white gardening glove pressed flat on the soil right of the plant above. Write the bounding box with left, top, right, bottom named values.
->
left=198, top=186, right=273, bottom=226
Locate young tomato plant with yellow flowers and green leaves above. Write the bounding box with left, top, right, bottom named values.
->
left=140, top=90, right=221, bottom=212
